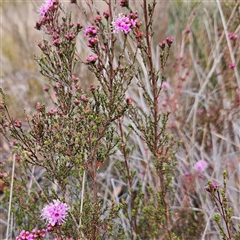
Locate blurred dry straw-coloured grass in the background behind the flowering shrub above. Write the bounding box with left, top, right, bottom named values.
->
left=0, top=1, right=240, bottom=240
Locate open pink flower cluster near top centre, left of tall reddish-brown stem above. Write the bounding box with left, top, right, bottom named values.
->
left=112, top=13, right=137, bottom=34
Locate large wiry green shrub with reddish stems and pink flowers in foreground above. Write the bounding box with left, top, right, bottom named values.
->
left=1, top=1, right=177, bottom=239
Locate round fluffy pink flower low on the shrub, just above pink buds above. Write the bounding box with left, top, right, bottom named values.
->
left=41, top=200, right=68, bottom=226
